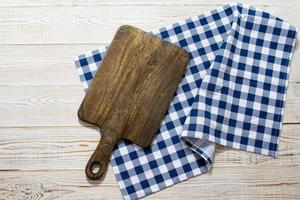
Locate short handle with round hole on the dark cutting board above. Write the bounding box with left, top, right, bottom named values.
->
left=85, top=129, right=118, bottom=180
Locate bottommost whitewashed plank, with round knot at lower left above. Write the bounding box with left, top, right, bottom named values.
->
left=0, top=153, right=300, bottom=199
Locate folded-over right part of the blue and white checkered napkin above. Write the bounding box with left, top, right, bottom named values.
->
left=181, top=6, right=296, bottom=156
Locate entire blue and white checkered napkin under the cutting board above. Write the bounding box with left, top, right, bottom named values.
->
left=75, top=4, right=296, bottom=199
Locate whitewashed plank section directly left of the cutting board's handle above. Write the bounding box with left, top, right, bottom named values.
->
left=0, top=127, right=100, bottom=170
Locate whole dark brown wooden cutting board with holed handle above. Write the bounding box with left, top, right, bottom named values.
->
left=78, top=25, right=189, bottom=180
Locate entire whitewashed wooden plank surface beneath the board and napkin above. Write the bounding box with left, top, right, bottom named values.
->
left=0, top=0, right=300, bottom=200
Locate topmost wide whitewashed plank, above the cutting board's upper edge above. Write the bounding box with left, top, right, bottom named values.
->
left=0, top=5, right=300, bottom=44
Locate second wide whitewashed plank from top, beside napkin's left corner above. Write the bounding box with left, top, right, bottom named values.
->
left=0, top=44, right=300, bottom=86
